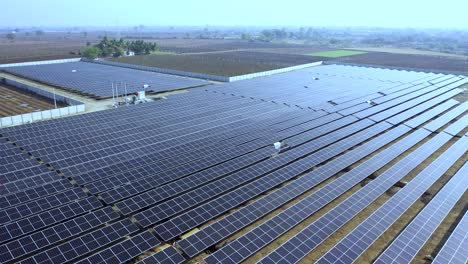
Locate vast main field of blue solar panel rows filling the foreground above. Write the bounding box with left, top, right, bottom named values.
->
left=0, top=65, right=468, bottom=263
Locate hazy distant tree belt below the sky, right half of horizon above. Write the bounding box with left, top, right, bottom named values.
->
left=240, top=27, right=468, bottom=55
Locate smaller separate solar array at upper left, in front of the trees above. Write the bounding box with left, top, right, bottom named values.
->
left=2, top=61, right=209, bottom=97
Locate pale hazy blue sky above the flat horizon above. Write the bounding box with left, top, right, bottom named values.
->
left=0, top=0, right=468, bottom=28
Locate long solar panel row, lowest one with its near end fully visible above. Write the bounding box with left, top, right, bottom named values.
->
left=177, top=123, right=409, bottom=257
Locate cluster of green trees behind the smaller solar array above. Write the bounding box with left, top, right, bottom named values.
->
left=83, top=37, right=159, bottom=59
